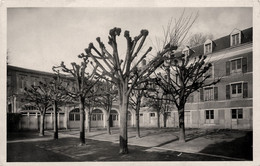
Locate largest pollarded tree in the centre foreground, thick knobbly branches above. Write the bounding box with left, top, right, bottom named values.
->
left=85, top=28, right=176, bottom=154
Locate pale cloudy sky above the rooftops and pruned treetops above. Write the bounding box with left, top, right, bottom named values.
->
left=7, top=7, right=253, bottom=72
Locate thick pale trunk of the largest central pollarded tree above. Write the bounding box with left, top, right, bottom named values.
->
left=119, top=82, right=129, bottom=154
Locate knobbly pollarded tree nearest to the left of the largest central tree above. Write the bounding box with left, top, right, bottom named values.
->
left=53, top=54, right=98, bottom=145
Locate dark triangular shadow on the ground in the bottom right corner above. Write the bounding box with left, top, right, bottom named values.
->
left=200, top=131, right=253, bottom=160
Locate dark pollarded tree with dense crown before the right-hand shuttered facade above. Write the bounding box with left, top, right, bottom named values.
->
left=156, top=54, right=220, bottom=142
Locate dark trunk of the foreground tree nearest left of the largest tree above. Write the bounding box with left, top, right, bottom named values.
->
left=79, top=96, right=85, bottom=145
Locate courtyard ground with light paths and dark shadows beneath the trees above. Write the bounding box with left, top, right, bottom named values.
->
left=7, top=128, right=252, bottom=162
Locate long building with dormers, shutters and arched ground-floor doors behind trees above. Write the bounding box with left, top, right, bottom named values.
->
left=7, top=28, right=253, bottom=129
